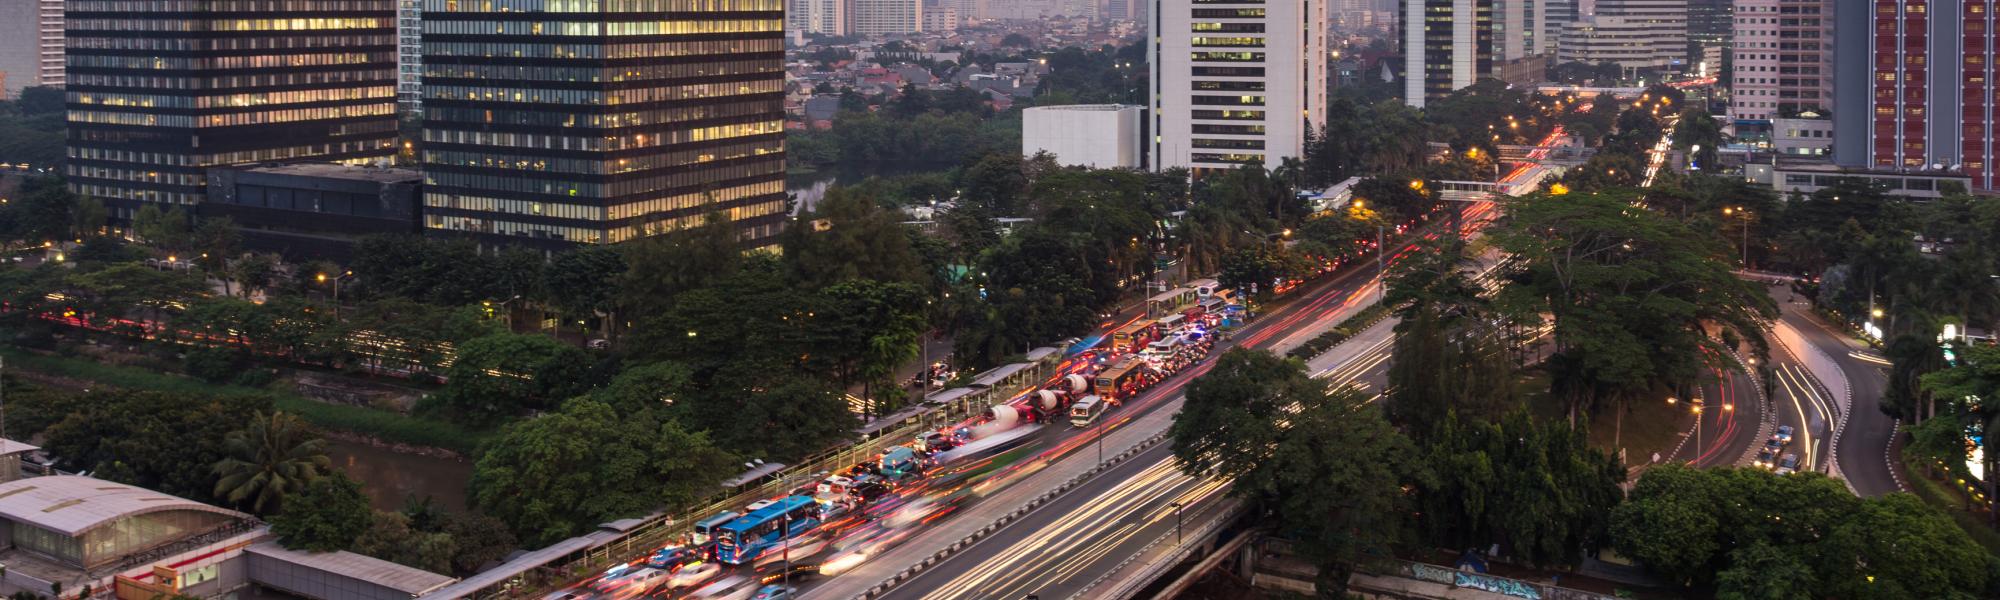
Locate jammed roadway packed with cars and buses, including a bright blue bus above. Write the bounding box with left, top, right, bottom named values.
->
left=548, top=288, right=1244, bottom=600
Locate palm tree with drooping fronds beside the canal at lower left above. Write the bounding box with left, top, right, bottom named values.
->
left=214, top=410, right=334, bottom=514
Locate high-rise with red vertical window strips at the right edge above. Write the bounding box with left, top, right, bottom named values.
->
left=1834, top=0, right=2000, bottom=190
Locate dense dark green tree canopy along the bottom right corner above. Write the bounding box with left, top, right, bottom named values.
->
left=1612, top=466, right=1996, bottom=598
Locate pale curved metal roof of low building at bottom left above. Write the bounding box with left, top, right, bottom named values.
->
left=0, top=476, right=250, bottom=538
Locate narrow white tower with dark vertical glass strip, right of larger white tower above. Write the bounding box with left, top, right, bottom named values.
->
left=1402, top=0, right=1494, bottom=108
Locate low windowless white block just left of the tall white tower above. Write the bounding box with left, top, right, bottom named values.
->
left=1020, top=104, right=1146, bottom=168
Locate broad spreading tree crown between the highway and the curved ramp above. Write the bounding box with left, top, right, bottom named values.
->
left=1494, top=190, right=1776, bottom=432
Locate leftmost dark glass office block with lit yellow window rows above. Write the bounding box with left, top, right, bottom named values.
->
left=64, top=0, right=396, bottom=218
